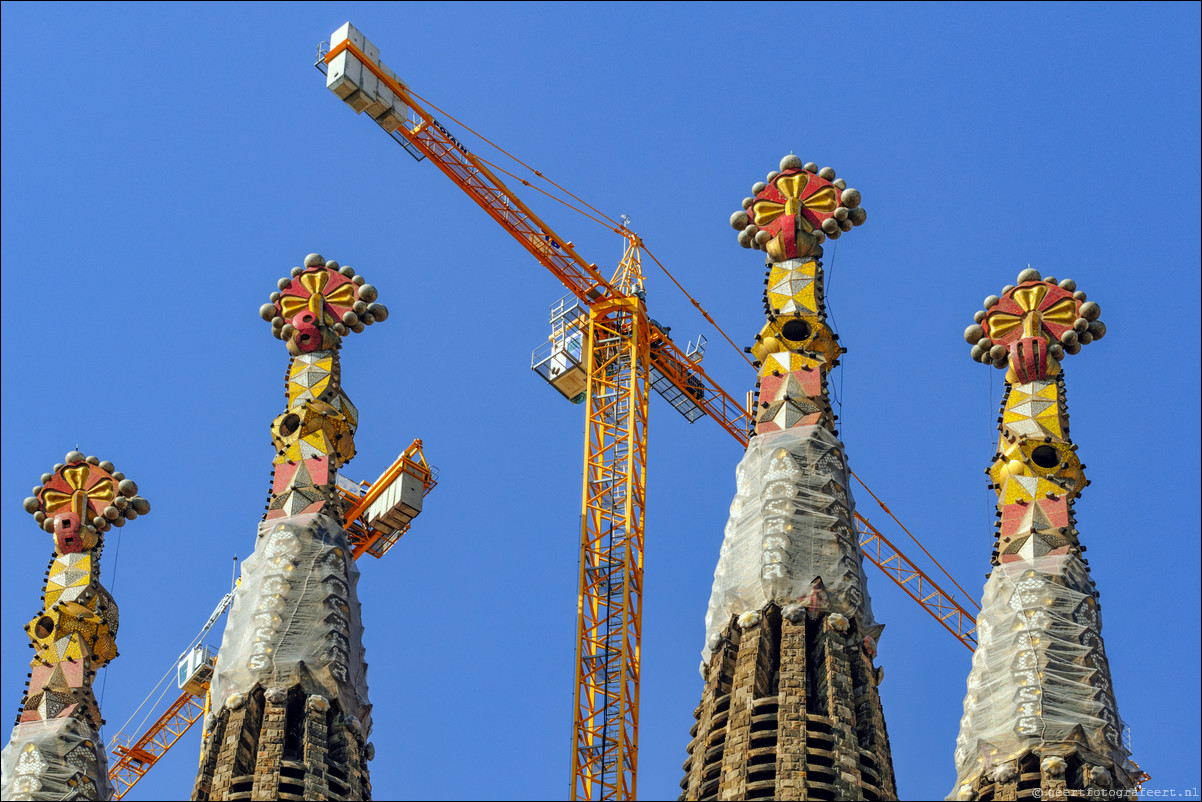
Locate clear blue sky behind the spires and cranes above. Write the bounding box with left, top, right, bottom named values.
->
left=0, top=2, right=1200, bottom=800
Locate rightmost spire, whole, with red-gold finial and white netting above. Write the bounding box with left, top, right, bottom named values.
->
left=948, top=268, right=1142, bottom=800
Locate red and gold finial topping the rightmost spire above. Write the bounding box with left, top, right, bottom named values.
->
left=964, top=267, right=1106, bottom=382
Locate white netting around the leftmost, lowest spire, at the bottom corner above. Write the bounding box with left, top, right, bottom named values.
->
left=0, top=717, right=113, bottom=800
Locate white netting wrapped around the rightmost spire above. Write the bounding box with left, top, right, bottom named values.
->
left=950, top=554, right=1137, bottom=798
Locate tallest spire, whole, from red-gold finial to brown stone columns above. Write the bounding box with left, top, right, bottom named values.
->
left=680, top=156, right=897, bottom=800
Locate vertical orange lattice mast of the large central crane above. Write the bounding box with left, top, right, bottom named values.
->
left=572, top=237, right=650, bottom=800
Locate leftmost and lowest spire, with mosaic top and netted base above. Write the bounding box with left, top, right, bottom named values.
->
left=0, top=451, right=150, bottom=800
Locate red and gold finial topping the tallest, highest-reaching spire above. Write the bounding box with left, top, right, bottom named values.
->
left=731, top=155, right=868, bottom=262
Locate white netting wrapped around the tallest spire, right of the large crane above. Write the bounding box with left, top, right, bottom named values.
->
left=701, top=426, right=880, bottom=663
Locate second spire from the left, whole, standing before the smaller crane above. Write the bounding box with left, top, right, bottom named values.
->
left=192, top=254, right=388, bottom=800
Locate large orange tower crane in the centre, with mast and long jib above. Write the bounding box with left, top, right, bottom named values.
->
left=316, top=23, right=976, bottom=800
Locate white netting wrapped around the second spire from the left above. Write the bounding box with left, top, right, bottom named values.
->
left=210, top=513, right=369, bottom=726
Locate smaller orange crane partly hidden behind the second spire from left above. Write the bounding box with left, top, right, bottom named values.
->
left=108, top=440, right=438, bottom=800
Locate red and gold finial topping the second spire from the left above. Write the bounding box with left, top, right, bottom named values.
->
left=258, top=254, right=388, bottom=356
